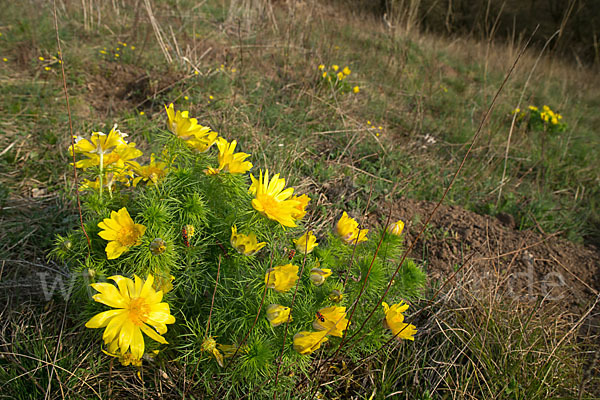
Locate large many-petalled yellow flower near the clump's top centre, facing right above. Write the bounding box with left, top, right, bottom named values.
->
left=248, top=170, right=302, bottom=227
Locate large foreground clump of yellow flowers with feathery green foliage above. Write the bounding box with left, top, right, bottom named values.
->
left=53, top=101, right=426, bottom=394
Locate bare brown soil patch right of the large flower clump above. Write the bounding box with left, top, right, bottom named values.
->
left=383, top=199, right=600, bottom=310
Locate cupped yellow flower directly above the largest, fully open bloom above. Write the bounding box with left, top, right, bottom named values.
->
left=98, top=207, right=146, bottom=260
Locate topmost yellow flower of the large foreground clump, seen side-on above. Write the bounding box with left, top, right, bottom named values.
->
left=165, top=103, right=219, bottom=153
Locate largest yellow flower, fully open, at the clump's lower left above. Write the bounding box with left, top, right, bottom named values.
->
left=85, top=275, right=175, bottom=360
